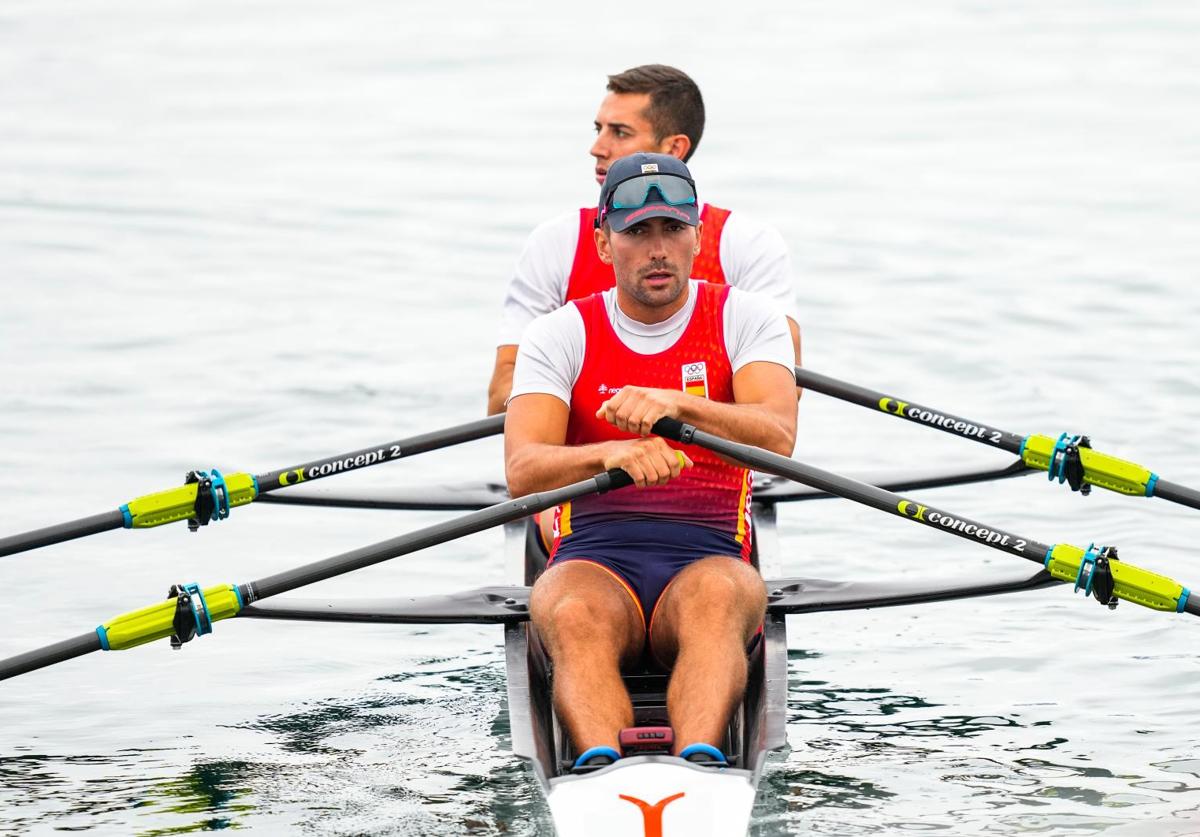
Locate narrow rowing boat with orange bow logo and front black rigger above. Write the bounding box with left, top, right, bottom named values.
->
left=239, top=500, right=1055, bottom=837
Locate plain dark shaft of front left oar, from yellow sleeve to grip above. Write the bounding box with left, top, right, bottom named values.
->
left=239, top=470, right=630, bottom=604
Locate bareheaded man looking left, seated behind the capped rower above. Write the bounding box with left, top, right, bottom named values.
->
left=487, top=64, right=800, bottom=415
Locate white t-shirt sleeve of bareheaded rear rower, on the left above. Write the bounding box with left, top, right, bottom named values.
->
left=497, top=210, right=580, bottom=345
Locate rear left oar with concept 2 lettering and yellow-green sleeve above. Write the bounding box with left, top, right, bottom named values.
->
left=0, top=414, right=504, bottom=556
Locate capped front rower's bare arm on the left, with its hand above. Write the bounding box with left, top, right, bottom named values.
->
left=504, top=392, right=691, bottom=496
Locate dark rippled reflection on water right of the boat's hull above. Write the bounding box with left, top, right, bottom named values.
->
left=752, top=652, right=1200, bottom=835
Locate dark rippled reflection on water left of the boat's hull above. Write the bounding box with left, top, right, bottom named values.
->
left=0, top=651, right=547, bottom=836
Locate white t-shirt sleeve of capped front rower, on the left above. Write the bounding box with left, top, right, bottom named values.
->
left=509, top=305, right=587, bottom=407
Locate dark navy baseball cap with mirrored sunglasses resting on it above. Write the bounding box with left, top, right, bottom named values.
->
left=596, top=151, right=700, bottom=233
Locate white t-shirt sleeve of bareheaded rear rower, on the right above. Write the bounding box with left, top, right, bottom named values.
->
left=721, top=211, right=797, bottom=320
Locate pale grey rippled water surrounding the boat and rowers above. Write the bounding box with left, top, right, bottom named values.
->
left=0, top=0, right=1200, bottom=835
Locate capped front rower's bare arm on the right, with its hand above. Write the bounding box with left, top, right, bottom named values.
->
left=596, top=361, right=796, bottom=456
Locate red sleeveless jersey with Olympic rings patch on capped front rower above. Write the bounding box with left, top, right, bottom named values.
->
left=557, top=282, right=751, bottom=558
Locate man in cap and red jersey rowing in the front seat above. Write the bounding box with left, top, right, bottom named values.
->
left=505, top=153, right=796, bottom=767
